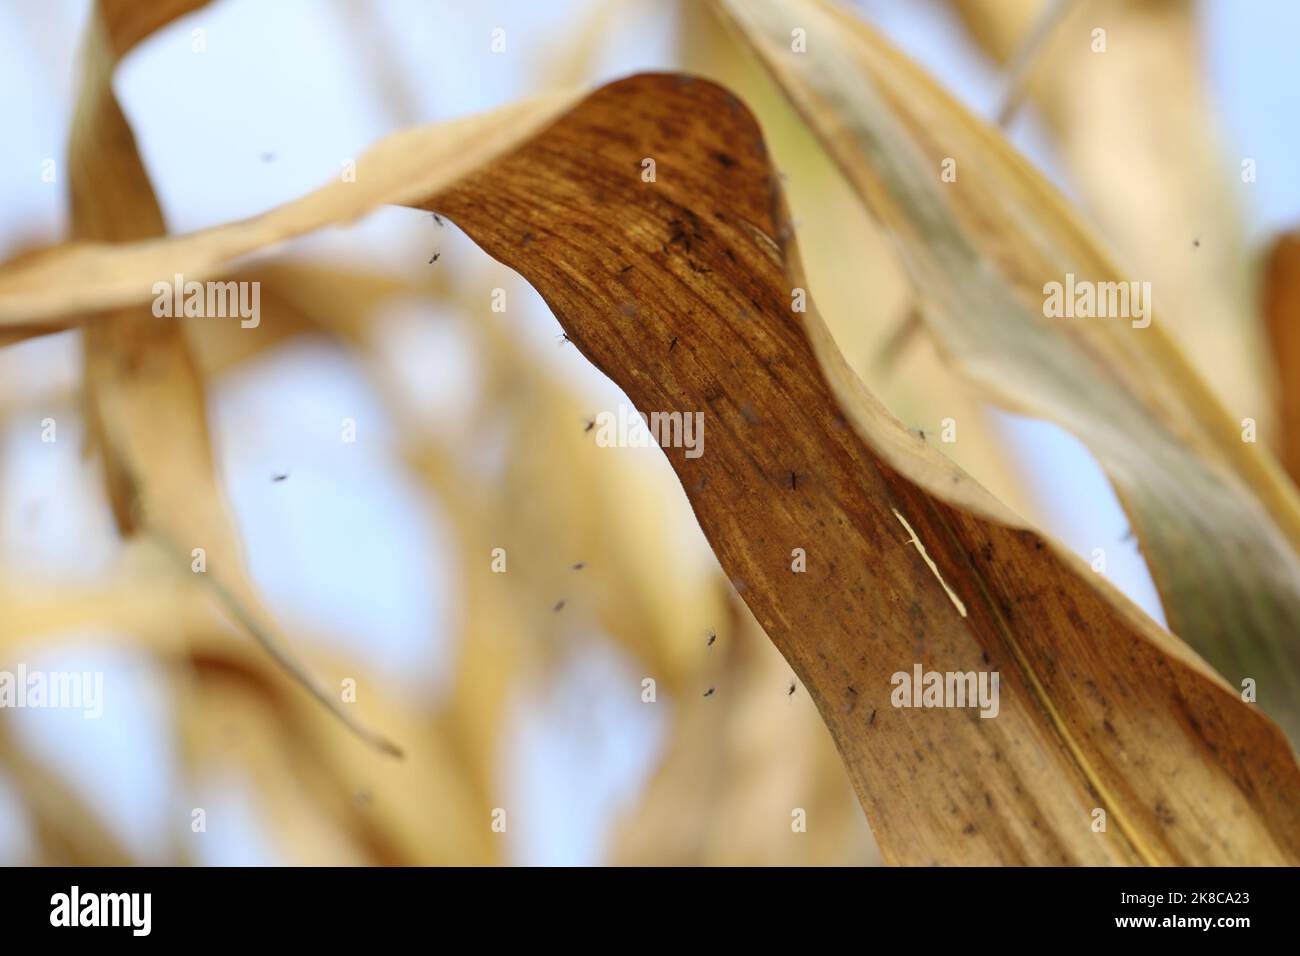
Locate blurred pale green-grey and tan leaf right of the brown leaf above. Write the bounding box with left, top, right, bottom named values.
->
left=718, top=0, right=1300, bottom=740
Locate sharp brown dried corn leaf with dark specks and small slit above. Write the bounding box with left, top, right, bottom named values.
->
left=0, top=75, right=1300, bottom=864
